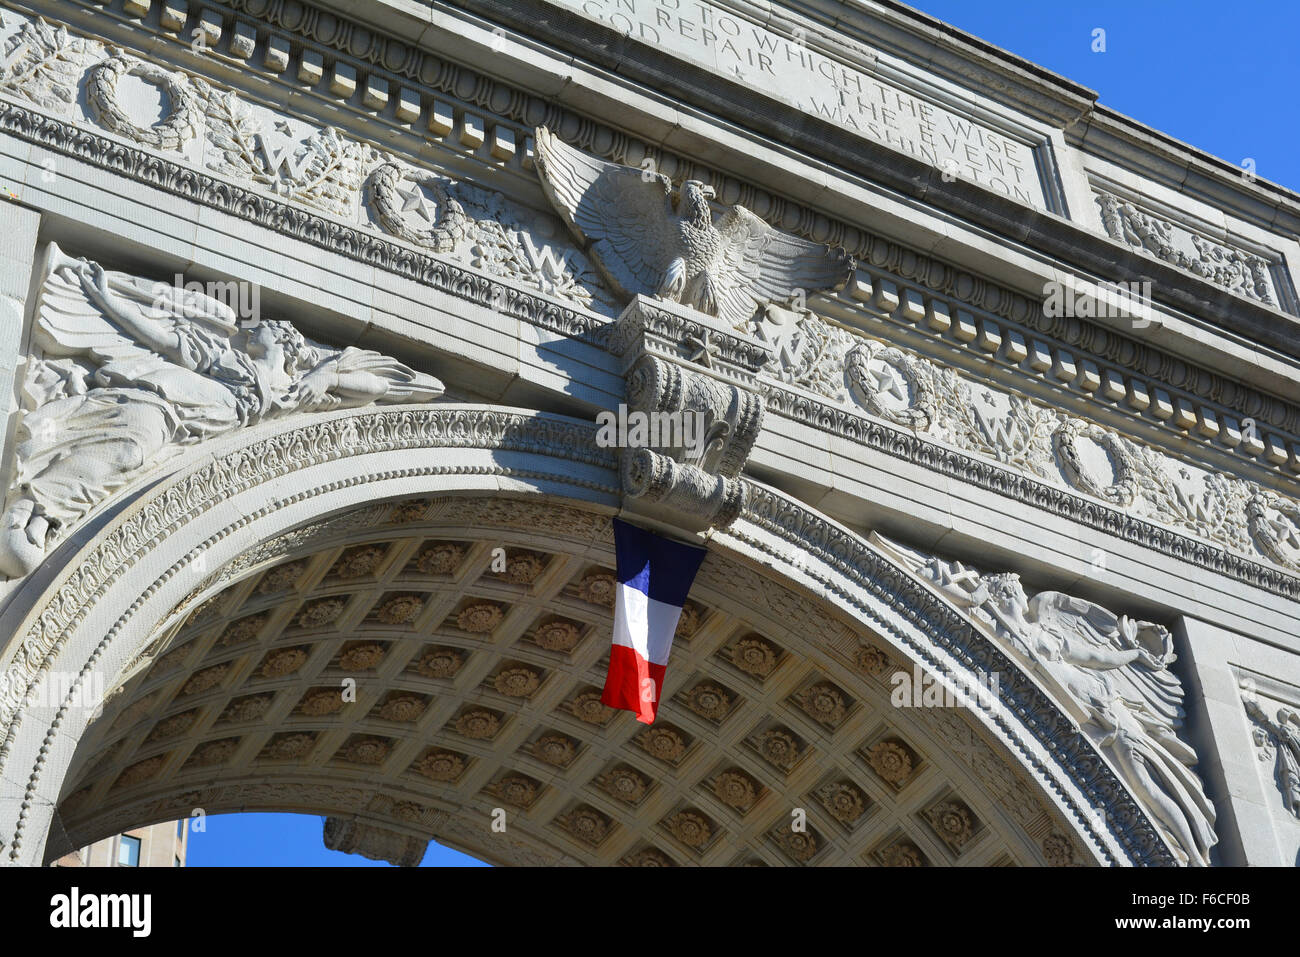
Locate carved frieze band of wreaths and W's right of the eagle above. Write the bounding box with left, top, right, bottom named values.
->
left=759, top=309, right=1300, bottom=571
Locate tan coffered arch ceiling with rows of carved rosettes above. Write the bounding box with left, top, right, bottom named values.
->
left=47, top=494, right=1091, bottom=865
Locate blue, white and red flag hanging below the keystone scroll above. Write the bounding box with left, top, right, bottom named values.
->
left=601, top=519, right=706, bottom=724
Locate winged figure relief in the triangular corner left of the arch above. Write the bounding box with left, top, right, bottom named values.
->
left=0, top=244, right=442, bottom=577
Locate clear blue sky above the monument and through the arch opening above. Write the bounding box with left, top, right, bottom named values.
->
left=189, top=0, right=1300, bottom=867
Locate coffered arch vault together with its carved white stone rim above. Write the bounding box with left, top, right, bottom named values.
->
left=0, top=406, right=1167, bottom=865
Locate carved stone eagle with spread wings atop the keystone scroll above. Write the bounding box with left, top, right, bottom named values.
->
left=534, top=126, right=854, bottom=329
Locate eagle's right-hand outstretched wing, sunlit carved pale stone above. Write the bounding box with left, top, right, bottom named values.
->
left=710, top=205, right=855, bottom=328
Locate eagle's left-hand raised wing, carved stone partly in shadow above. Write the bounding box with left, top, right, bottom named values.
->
left=534, top=126, right=681, bottom=298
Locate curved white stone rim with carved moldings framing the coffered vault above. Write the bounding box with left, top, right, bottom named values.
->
left=0, top=403, right=1174, bottom=865
